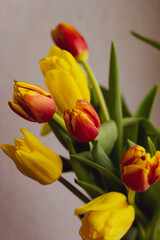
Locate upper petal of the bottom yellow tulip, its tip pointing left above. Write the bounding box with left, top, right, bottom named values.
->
left=74, top=192, right=127, bottom=215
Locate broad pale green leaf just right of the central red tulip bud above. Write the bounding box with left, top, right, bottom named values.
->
left=97, top=120, right=117, bottom=154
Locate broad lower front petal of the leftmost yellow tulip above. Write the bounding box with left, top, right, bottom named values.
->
left=16, top=150, right=61, bottom=184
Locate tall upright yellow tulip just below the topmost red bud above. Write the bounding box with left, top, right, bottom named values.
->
left=40, top=46, right=90, bottom=113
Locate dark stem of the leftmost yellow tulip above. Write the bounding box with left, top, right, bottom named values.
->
left=58, top=176, right=90, bottom=203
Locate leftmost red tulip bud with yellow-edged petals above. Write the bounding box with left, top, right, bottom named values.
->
left=8, top=82, right=56, bottom=123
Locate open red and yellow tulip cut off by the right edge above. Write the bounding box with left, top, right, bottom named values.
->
left=120, top=145, right=160, bottom=192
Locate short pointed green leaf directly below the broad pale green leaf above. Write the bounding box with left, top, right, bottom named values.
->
left=92, top=140, right=115, bottom=174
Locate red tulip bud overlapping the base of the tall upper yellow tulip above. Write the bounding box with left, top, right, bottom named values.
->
left=63, top=99, right=100, bottom=142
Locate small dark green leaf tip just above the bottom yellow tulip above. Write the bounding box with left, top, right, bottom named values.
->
left=75, top=180, right=105, bottom=198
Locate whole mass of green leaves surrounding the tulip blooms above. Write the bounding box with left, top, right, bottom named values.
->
left=49, top=35, right=160, bottom=240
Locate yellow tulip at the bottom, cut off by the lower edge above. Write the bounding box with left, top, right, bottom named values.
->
left=75, top=192, right=135, bottom=240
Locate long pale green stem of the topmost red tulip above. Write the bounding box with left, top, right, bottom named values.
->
left=81, top=60, right=110, bottom=121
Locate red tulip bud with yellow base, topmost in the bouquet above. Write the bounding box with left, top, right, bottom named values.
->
left=51, top=23, right=88, bottom=61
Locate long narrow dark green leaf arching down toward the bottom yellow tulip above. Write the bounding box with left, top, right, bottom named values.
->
left=71, top=154, right=123, bottom=191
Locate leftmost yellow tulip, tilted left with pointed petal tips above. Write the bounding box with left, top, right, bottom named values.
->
left=1, top=129, right=62, bottom=185
